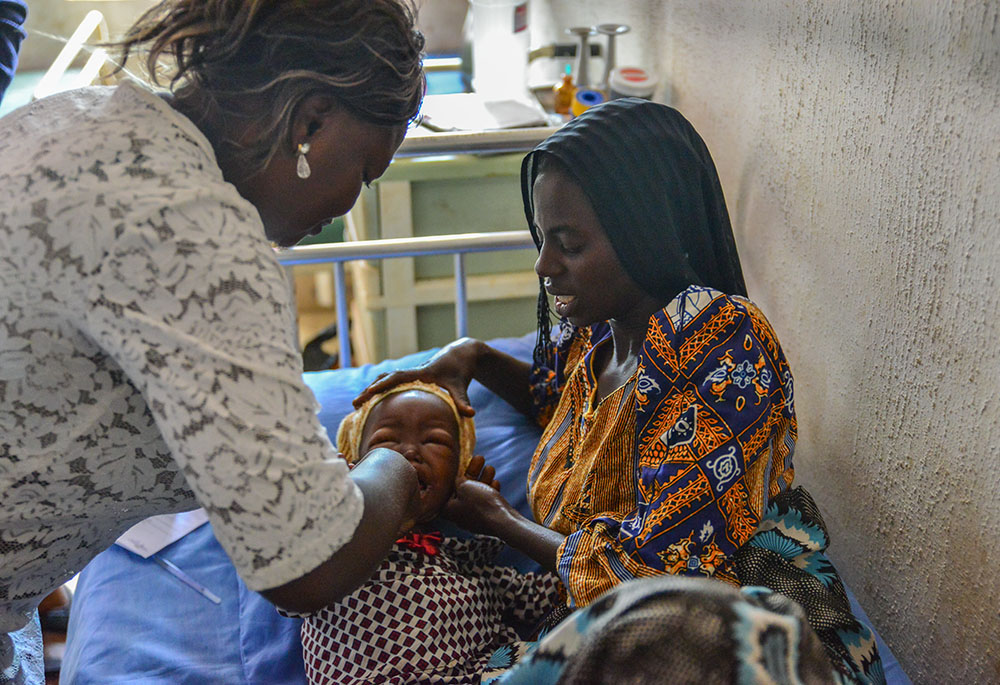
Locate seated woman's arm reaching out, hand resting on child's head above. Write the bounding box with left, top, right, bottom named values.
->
left=354, top=338, right=532, bottom=416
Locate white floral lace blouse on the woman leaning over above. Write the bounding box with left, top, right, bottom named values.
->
left=0, top=83, right=363, bottom=632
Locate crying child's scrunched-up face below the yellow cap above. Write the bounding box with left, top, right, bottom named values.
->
left=360, top=390, right=460, bottom=522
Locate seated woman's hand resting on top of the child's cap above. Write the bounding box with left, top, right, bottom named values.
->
left=354, top=338, right=481, bottom=416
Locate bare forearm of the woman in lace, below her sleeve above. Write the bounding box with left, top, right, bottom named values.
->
left=261, top=449, right=419, bottom=613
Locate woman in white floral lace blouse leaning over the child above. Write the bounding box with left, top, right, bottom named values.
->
left=0, top=0, right=438, bottom=682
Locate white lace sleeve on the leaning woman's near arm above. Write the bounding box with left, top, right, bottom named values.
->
left=85, top=191, right=363, bottom=590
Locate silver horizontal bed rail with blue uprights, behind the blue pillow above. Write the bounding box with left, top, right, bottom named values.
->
left=277, top=231, right=535, bottom=368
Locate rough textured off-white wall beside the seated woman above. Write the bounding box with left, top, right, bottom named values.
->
left=543, top=0, right=1000, bottom=683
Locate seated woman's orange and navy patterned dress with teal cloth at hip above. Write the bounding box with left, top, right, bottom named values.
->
left=528, top=286, right=884, bottom=683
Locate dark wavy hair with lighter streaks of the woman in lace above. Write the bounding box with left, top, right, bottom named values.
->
left=117, top=0, right=424, bottom=176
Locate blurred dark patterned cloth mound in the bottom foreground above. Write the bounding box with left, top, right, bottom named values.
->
left=488, top=575, right=839, bottom=685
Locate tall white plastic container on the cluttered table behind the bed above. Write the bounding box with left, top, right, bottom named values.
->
left=469, top=0, right=529, bottom=100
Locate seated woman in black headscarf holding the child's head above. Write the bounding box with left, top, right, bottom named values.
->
left=362, top=99, right=881, bottom=682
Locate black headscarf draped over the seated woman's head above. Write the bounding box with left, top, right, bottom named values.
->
left=521, top=98, right=746, bottom=306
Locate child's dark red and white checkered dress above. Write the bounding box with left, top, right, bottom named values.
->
left=288, top=535, right=561, bottom=685
